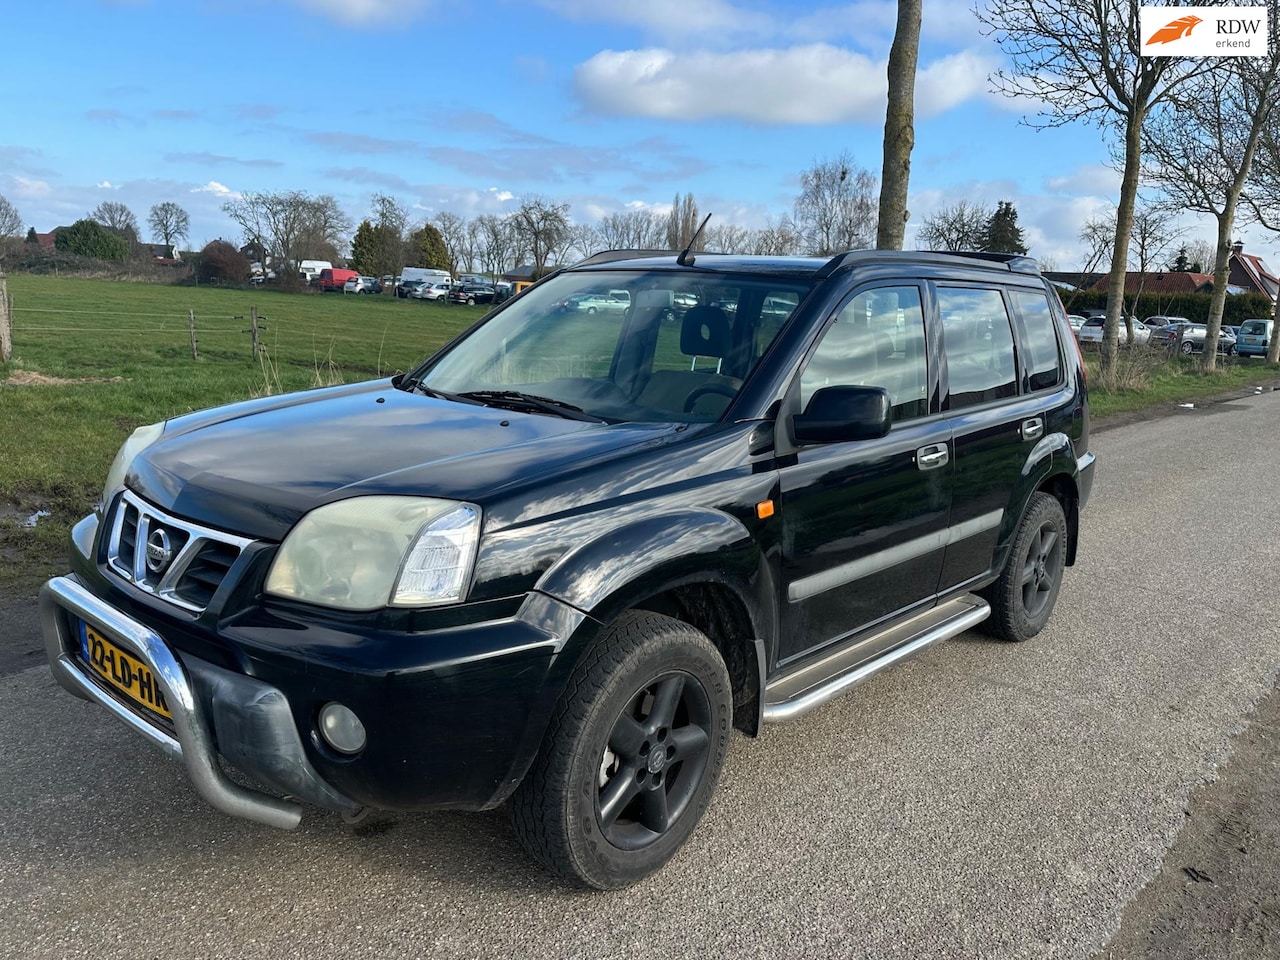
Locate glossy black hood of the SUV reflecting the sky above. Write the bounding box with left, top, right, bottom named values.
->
left=127, top=380, right=676, bottom=540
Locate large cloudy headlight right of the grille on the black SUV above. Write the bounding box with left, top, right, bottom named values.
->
left=266, top=497, right=480, bottom=611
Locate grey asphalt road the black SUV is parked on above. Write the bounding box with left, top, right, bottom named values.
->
left=0, top=393, right=1280, bottom=959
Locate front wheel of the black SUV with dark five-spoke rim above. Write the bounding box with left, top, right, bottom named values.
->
left=509, top=611, right=733, bottom=890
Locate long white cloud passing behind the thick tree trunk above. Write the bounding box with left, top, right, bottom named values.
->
left=575, top=44, right=993, bottom=124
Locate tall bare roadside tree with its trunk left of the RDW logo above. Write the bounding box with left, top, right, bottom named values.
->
left=977, top=0, right=1217, bottom=384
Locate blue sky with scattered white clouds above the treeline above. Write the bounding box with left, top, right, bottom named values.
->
left=0, top=0, right=1280, bottom=269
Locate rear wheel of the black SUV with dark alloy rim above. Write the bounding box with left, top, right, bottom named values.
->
left=983, top=493, right=1066, bottom=643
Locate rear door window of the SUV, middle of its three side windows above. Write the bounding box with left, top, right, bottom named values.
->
left=938, top=287, right=1018, bottom=410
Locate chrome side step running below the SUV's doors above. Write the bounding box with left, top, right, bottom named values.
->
left=764, top=594, right=991, bottom=723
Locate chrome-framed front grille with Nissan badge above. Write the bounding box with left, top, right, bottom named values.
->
left=106, top=490, right=251, bottom=613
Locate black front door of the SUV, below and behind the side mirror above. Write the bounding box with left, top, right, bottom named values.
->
left=778, top=283, right=951, bottom=663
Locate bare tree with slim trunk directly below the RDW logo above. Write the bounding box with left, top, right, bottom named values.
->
left=1146, top=48, right=1280, bottom=370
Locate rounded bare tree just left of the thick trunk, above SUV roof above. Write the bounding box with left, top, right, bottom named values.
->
left=791, top=150, right=880, bottom=256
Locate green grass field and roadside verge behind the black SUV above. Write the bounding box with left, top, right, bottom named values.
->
left=0, top=275, right=1277, bottom=590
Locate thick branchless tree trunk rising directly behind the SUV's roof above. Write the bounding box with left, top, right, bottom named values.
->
left=876, top=0, right=922, bottom=250
